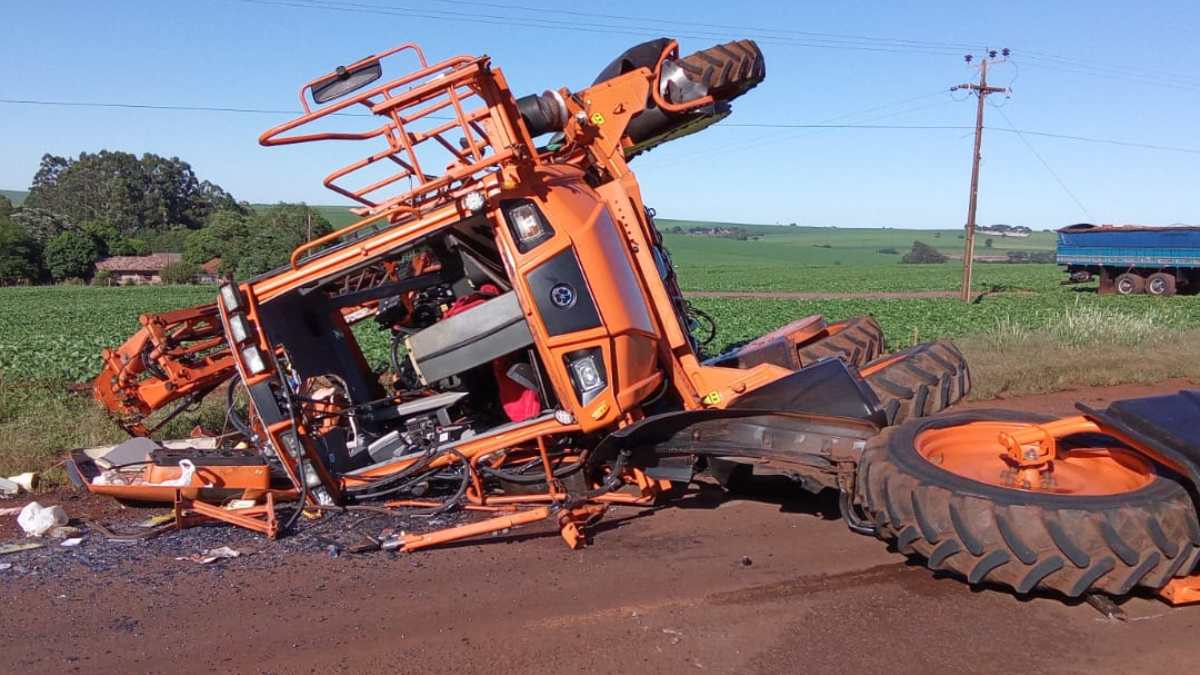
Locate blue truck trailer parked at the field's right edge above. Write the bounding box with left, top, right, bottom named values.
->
left=1056, top=223, right=1200, bottom=295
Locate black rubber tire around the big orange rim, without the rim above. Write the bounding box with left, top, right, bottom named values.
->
left=856, top=411, right=1200, bottom=597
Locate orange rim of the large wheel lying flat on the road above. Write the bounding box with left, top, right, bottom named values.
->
left=914, top=422, right=1156, bottom=496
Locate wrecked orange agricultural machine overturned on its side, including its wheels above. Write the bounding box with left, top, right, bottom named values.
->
left=70, top=38, right=1200, bottom=601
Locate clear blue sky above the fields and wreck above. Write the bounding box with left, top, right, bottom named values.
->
left=0, top=0, right=1200, bottom=228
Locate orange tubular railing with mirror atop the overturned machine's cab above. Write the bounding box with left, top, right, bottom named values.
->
left=259, top=43, right=538, bottom=267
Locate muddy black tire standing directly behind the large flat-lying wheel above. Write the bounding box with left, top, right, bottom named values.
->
left=860, top=340, right=971, bottom=426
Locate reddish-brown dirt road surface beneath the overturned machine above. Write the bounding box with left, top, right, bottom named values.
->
left=0, top=383, right=1200, bottom=675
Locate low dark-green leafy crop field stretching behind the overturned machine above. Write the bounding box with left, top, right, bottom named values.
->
left=0, top=278, right=1200, bottom=381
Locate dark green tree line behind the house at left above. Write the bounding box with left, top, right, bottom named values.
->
left=0, top=150, right=332, bottom=283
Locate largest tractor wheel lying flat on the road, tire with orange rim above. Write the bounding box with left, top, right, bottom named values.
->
left=856, top=411, right=1200, bottom=597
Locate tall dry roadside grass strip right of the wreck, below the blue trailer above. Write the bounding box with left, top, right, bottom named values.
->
left=955, top=299, right=1200, bottom=400
